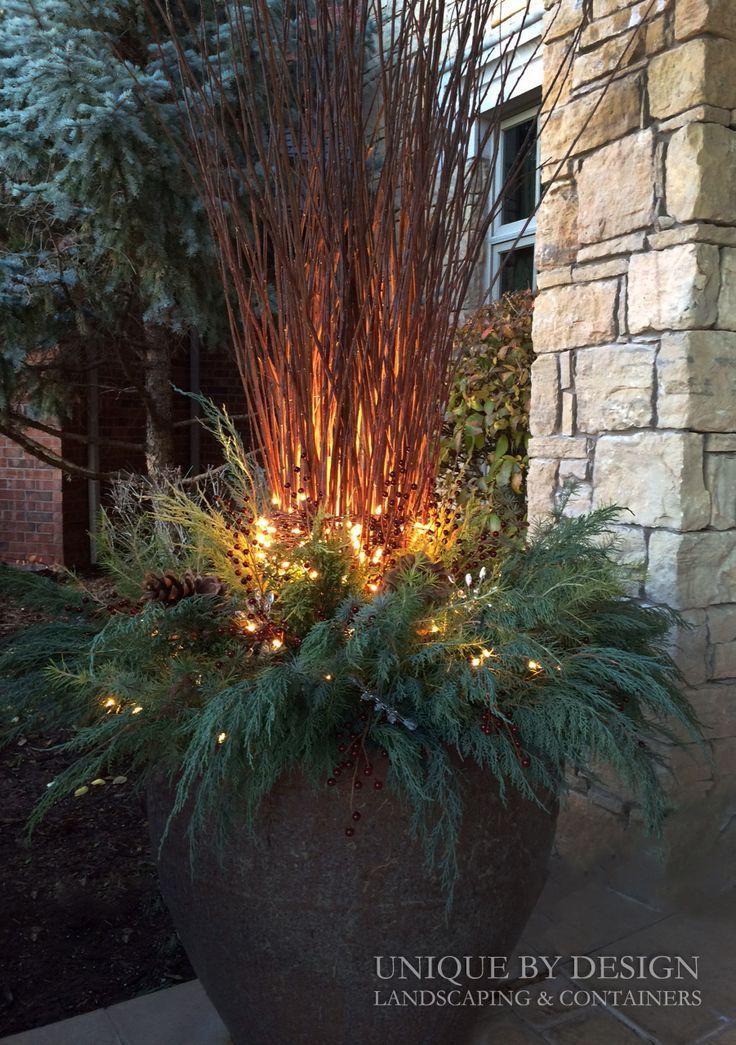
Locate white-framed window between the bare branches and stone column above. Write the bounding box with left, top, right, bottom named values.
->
left=487, top=110, right=539, bottom=298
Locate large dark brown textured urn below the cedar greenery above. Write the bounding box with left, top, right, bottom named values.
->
left=148, top=767, right=556, bottom=1045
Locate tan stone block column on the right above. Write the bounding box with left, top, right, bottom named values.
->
left=529, top=0, right=736, bottom=810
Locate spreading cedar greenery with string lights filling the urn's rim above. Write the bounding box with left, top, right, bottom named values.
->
left=0, top=410, right=697, bottom=898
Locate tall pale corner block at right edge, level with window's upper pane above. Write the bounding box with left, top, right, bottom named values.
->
left=665, top=124, right=736, bottom=224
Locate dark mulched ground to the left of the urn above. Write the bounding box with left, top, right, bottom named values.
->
left=0, top=581, right=194, bottom=1037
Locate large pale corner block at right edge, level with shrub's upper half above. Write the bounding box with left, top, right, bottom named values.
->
left=657, top=330, right=736, bottom=433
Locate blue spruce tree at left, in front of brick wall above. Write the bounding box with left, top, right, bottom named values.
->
left=0, top=0, right=226, bottom=470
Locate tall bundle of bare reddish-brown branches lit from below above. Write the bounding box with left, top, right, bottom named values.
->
left=150, top=0, right=581, bottom=527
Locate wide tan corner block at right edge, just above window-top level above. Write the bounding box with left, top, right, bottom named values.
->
left=648, top=38, right=736, bottom=119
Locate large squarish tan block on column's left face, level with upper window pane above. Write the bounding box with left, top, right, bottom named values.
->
left=577, top=130, right=654, bottom=243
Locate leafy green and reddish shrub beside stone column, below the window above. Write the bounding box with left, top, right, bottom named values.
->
left=440, top=291, right=534, bottom=537
